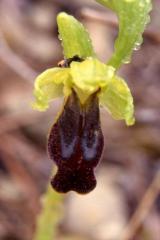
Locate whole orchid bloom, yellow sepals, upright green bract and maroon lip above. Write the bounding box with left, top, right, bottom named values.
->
left=33, top=0, right=151, bottom=193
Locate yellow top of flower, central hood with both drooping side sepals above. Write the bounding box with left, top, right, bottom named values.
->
left=33, top=57, right=134, bottom=125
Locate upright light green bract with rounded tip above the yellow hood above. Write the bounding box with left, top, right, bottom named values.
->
left=57, top=13, right=95, bottom=58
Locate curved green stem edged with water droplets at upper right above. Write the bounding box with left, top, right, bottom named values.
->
left=96, top=0, right=152, bottom=68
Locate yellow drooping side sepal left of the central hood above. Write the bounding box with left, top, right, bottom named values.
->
left=32, top=68, right=69, bottom=111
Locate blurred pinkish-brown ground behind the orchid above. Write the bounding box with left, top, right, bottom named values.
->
left=0, top=0, right=160, bottom=240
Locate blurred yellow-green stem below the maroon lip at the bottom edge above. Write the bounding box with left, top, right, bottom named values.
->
left=33, top=178, right=63, bottom=240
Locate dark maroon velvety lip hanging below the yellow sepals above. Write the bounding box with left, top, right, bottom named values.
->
left=48, top=91, right=103, bottom=193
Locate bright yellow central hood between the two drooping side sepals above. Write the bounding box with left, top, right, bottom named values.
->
left=71, top=58, right=115, bottom=104
